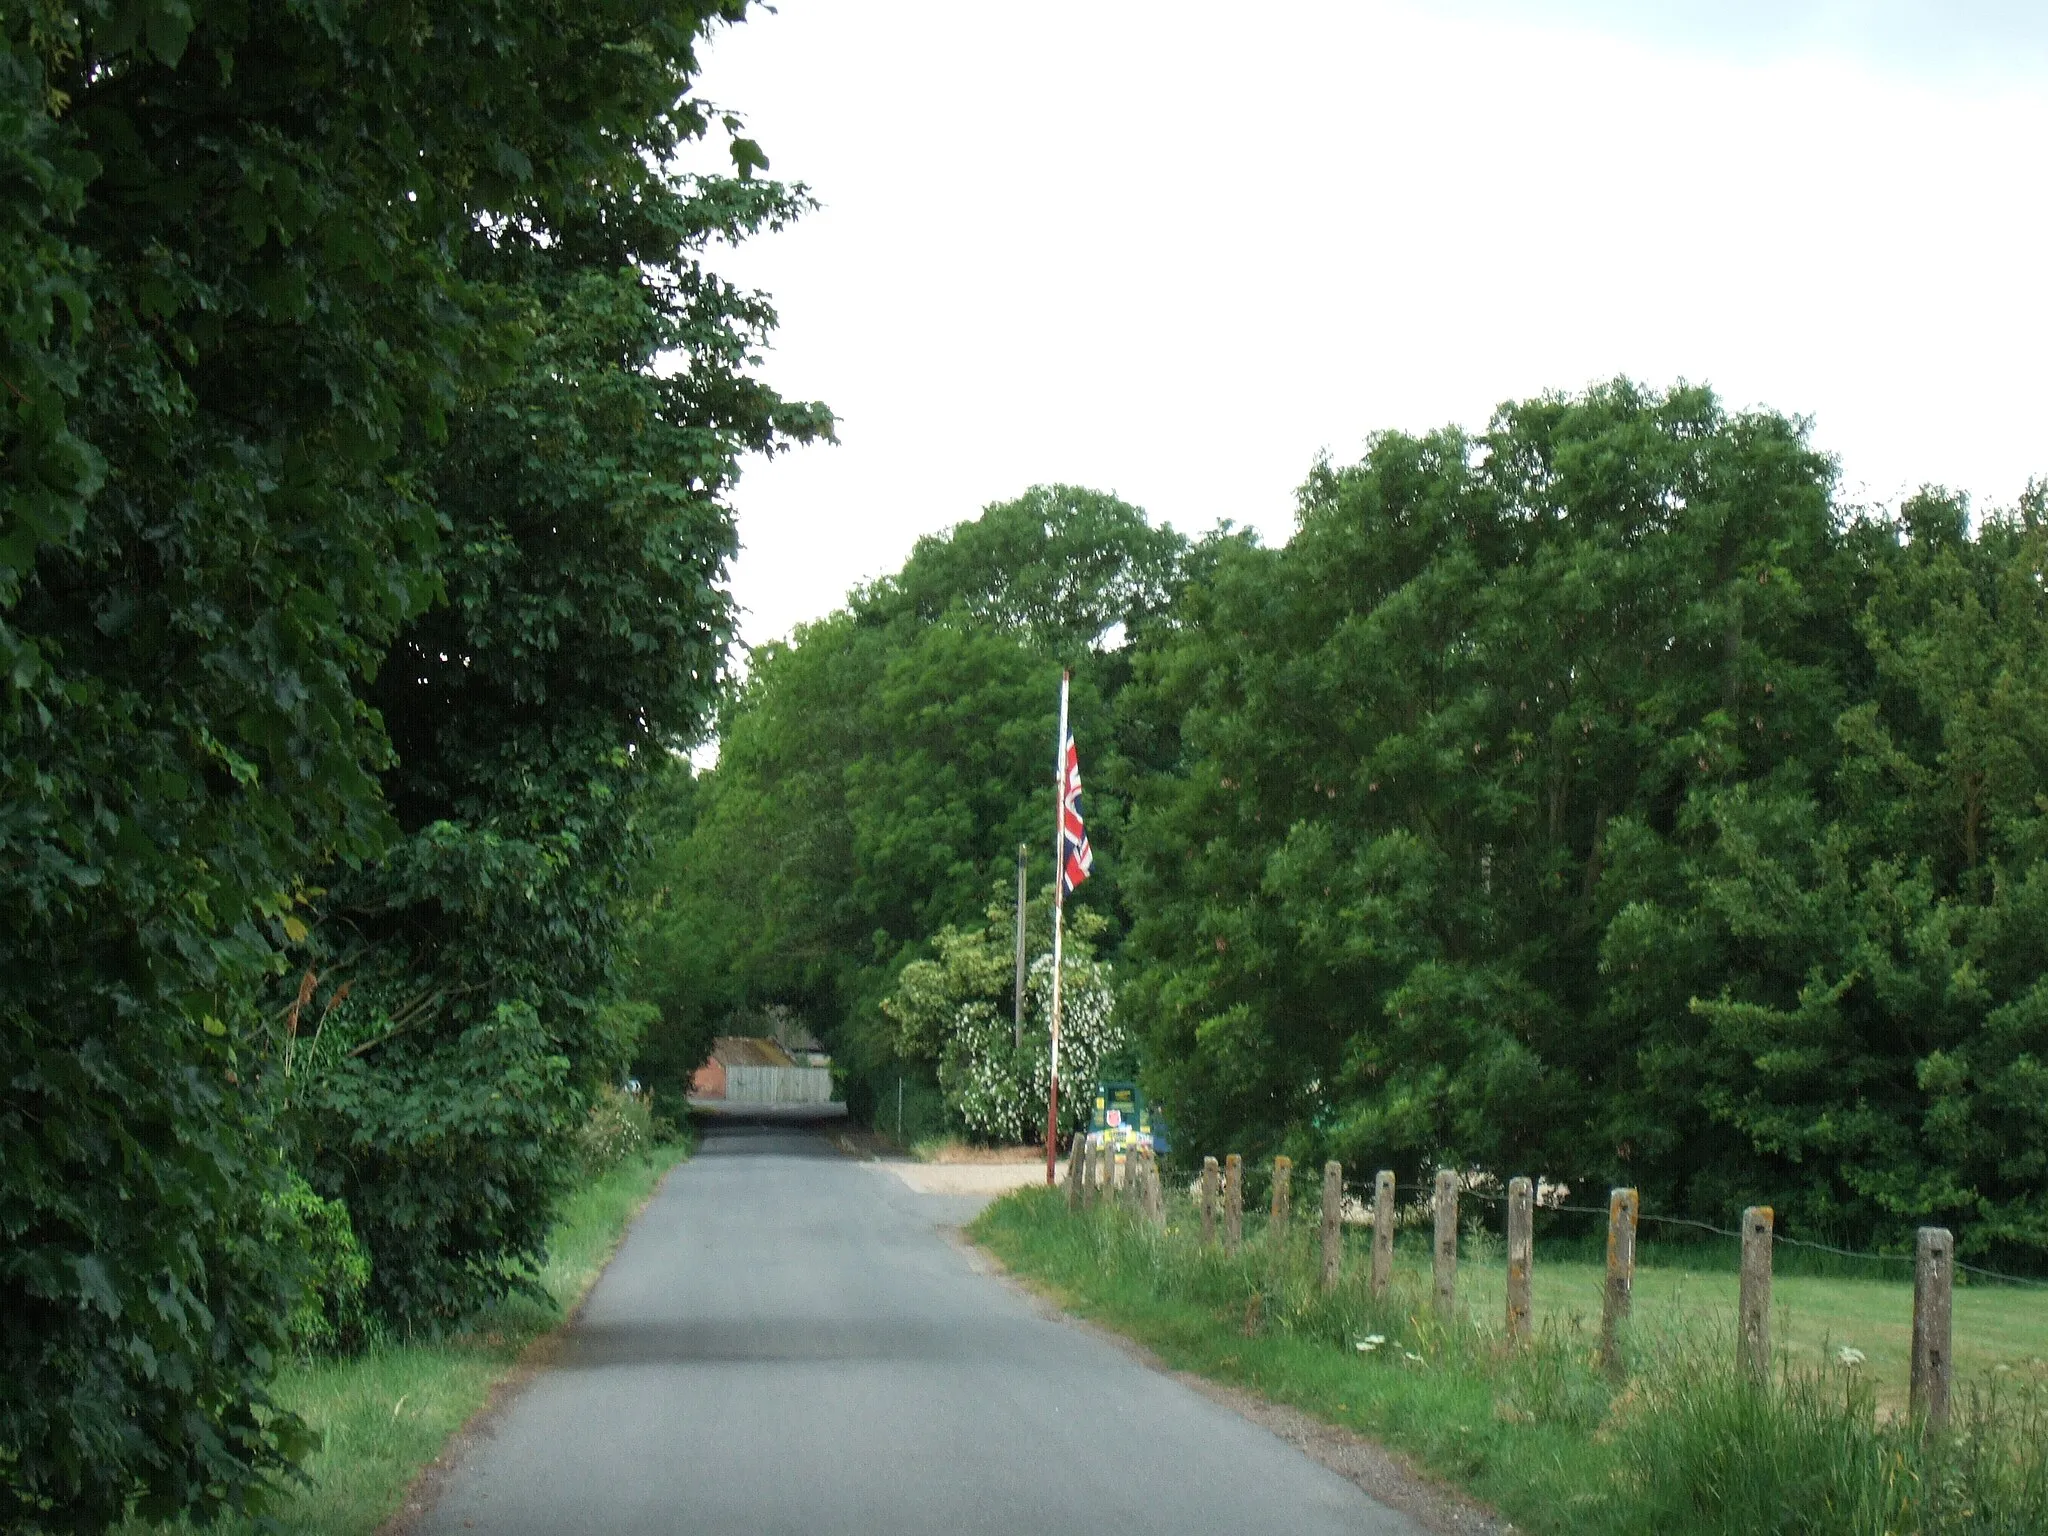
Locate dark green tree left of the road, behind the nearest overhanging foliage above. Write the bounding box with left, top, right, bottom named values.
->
left=286, top=172, right=829, bottom=1323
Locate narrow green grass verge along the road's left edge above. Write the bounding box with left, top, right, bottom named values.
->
left=125, top=1147, right=686, bottom=1536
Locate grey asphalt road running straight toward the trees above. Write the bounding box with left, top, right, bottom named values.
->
left=420, top=1124, right=1417, bottom=1536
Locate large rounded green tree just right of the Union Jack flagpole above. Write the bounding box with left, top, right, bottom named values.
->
left=1126, top=385, right=1849, bottom=1174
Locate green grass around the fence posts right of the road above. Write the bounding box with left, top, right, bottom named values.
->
left=973, top=1190, right=2048, bottom=1536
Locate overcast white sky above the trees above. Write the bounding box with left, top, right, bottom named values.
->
left=702, top=0, right=2048, bottom=643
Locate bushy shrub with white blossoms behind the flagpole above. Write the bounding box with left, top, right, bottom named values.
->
left=883, top=913, right=1124, bottom=1143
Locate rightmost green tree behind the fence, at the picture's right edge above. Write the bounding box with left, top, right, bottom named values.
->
left=1604, top=494, right=2048, bottom=1266
